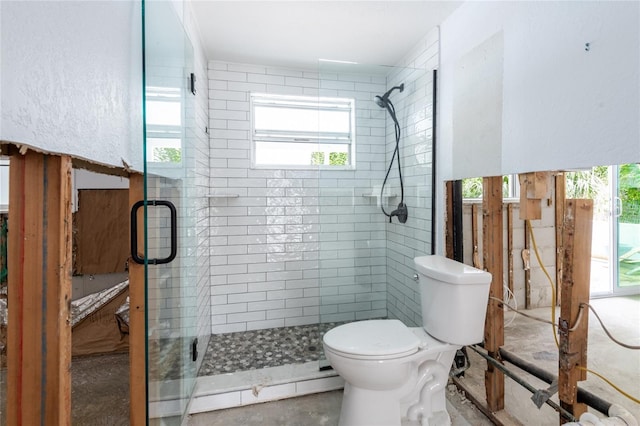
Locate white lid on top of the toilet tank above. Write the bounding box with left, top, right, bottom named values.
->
left=413, top=255, right=491, bottom=284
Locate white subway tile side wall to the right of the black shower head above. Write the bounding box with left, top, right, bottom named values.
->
left=386, top=28, right=439, bottom=326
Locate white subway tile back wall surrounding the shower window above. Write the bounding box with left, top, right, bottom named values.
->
left=209, top=61, right=386, bottom=333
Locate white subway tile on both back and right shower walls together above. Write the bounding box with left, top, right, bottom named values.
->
left=209, top=30, right=438, bottom=334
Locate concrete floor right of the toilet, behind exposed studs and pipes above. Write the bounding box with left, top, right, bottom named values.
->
left=462, top=296, right=640, bottom=426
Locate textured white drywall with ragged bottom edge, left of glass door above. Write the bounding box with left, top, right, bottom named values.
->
left=0, top=1, right=142, bottom=170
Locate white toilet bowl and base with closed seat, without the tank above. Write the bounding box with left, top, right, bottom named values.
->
left=323, top=319, right=460, bottom=426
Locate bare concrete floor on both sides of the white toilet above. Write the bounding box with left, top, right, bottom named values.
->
left=189, top=296, right=640, bottom=426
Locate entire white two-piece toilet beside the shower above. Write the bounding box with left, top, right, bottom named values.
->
left=323, top=256, right=491, bottom=426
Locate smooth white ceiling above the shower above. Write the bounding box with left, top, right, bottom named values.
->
left=192, top=0, right=461, bottom=67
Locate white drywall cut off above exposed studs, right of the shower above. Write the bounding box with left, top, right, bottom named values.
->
left=438, top=2, right=640, bottom=180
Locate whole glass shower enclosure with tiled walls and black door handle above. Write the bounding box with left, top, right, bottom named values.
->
left=145, top=2, right=438, bottom=424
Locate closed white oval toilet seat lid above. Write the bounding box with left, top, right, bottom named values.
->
left=323, top=319, right=422, bottom=360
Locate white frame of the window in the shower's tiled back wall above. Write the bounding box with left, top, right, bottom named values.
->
left=250, top=93, right=356, bottom=170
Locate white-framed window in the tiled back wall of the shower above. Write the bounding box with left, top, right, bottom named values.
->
left=251, top=94, right=355, bottom=168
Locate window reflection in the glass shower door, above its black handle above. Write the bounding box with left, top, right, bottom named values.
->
left=146, top=87, right=182, bottom=163
